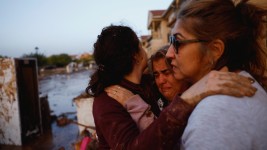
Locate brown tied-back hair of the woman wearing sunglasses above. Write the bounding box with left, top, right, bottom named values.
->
left=177, top=0, right=267, bottom=88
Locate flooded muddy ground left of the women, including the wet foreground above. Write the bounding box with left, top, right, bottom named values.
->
left=0, top=70, right=93, bottom=150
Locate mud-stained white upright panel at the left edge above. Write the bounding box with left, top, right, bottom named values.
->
left=0, top=58, right=22, bottom=145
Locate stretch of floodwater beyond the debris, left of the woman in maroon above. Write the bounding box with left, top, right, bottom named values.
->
left=39, top=70, right=92, bottom=116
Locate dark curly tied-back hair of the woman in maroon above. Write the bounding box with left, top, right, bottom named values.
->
left=86, top=25, right=140, bottom=96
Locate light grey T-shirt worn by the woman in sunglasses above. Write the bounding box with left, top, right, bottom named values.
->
left=181, top=71, right=267, bottom=150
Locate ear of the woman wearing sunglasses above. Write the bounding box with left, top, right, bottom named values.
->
left=209, top=39, right=225, bottom=62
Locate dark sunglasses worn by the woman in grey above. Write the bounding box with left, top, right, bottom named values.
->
left=169, top=34, right=207, bottom=54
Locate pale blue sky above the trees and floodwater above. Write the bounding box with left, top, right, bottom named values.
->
left=0, top=0, right=172, bottom=57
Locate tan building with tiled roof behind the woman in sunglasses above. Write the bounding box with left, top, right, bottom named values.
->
left=143, top=0, right=267, bottom=57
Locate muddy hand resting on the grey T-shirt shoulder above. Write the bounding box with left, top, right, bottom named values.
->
left=181, top=67, right=257, bottom=105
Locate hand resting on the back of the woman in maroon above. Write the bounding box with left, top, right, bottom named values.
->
left=105, top=85, right=134, bottom=106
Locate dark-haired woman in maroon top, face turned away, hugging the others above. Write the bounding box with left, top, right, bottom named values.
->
left=87, top=25, right=255, bottom=149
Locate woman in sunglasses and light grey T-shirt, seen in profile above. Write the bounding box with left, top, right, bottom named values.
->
left=166, top=0, right=267, bottom=150
